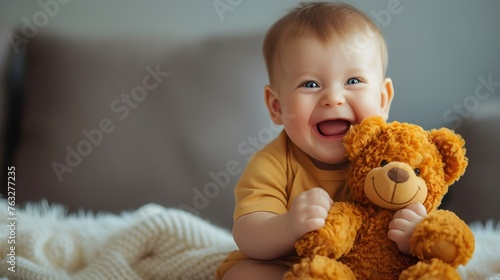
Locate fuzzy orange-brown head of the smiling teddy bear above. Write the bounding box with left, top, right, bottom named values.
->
left=344, top=116, right=467, bottom=211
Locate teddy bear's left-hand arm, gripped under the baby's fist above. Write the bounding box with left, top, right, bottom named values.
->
left=295, top=202, right=363, bottom=259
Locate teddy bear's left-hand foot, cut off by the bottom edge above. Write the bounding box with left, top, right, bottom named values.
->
left=284, top=256, right=356, bottom=280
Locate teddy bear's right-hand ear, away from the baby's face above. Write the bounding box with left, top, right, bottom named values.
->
left=429, top=128, right=467, bottom=185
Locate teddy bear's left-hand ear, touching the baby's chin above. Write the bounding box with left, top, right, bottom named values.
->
left=344, top=116, right=387, bottom=161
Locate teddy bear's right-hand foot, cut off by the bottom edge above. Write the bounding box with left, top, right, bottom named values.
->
left=399, top=259, right=461, bottom=280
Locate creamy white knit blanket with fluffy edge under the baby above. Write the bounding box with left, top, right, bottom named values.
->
left=0, top=200, right=500, bottom=280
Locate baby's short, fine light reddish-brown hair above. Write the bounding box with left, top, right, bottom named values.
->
left=263, top=3, right=388, bottom=83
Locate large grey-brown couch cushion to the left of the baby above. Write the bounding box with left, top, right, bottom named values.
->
left=16, top=34, right=279, bottom=228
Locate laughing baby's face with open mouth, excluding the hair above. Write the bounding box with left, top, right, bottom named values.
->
left=268, top=37, right=393, bottom=168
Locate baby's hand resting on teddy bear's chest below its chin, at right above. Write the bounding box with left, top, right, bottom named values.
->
left=387, top=202, right=427, bottom=254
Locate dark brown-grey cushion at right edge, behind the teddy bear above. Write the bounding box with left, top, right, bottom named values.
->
left=443, top=99, right=500, bottom=222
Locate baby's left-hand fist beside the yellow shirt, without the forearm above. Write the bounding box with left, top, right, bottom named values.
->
left=288, top=188, right=333, bottom=239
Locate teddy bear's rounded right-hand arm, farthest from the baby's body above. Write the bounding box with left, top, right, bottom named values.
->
left=410, top=210, right=474, bottom=267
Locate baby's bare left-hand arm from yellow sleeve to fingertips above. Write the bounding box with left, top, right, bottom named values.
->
left=233, top=188, right=333, bottom=260
